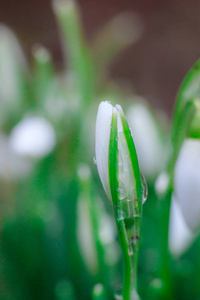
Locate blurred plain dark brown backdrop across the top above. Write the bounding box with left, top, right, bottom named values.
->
left=0, top=0, right=200, bottom=114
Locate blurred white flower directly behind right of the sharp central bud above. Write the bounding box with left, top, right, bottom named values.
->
left=127, top=103, right=166, bottom=180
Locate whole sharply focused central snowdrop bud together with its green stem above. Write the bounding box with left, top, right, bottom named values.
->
left=95, top=102, right=147, bottom=300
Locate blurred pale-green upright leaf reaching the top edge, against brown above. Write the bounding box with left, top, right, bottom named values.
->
left=53, top=0, right=95, bottom=105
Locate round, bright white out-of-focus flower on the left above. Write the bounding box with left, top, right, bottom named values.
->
left=9, top=116, right=56, bottom=157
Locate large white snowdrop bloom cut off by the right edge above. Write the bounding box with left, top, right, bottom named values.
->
left=174, top=138, right=200, bottom=231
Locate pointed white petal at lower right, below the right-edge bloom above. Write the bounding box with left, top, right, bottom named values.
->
left=169, top=197, right=196, bottom=256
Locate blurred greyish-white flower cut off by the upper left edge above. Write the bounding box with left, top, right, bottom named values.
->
left=0, top=25, right=28, bottom=123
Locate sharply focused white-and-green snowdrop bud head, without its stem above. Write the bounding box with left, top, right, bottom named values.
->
left=95, top=102, right=146, bottom=219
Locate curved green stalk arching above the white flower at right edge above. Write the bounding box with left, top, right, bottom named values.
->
left=169, top=60, right=200, bottom=179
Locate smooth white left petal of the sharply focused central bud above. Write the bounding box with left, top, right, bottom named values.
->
left=95, top=102, right=113, bottom=200
